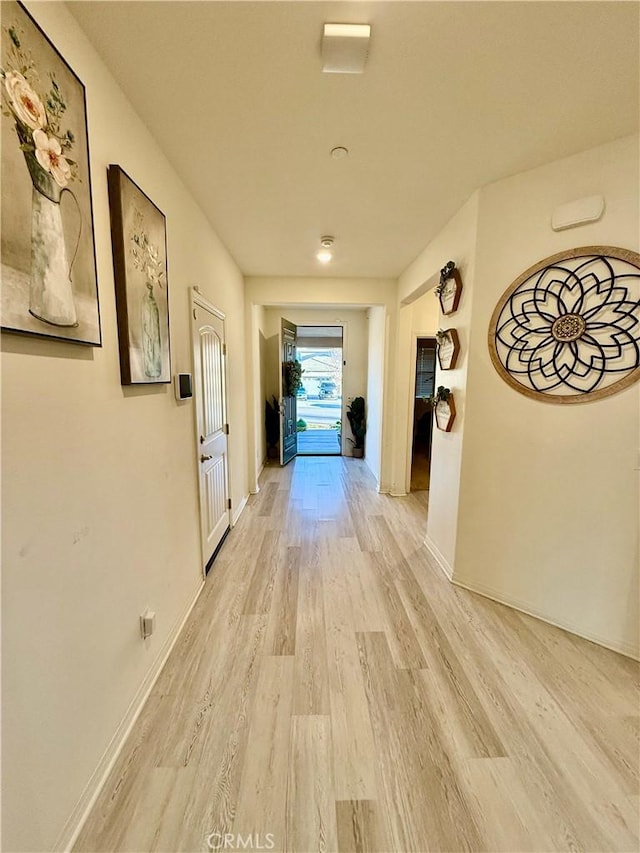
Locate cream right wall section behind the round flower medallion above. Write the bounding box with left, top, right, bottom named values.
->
left=456, top=133, right=640, bottom=655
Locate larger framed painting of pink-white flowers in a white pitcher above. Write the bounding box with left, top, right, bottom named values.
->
left=0, top=2, right=101, bottom=346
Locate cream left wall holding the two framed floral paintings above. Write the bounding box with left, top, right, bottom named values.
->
left=2, top=3, right=247, bottom=851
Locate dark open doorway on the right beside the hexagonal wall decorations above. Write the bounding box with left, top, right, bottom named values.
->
left=410, top=337, right=436, bottom=492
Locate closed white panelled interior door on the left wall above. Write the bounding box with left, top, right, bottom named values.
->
left=192, top=294, right=231, bottom=567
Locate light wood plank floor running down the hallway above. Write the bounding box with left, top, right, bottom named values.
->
left=75, top=457, right=640, bottom=853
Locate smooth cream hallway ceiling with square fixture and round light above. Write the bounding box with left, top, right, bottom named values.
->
left=69, top=0, right=640, bottom=276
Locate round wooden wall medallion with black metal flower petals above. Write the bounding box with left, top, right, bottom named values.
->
left=489, top=246, right=640, bottom=403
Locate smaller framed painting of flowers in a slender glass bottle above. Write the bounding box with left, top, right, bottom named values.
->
left=107, top=165, right=171, bottom=385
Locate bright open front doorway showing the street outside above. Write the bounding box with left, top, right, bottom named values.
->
left=297, top=326, right=344, bottom=456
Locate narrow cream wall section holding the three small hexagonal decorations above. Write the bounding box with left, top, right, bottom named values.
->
left=394, top=193, right=478, bottom=576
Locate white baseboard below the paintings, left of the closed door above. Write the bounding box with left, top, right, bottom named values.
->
left=53, top=580, right=204, bottom=853
